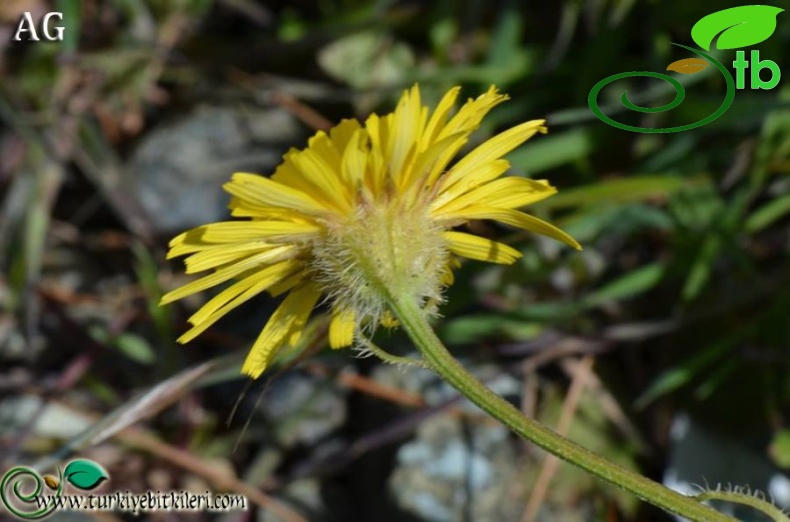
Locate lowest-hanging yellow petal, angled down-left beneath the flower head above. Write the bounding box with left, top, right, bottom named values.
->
left=241, top=284, right=321, bottom=379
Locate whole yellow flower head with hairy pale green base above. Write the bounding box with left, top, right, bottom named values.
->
left=162, top=85, right=580, bottom=377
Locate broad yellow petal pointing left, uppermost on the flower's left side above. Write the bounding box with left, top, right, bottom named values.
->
left=223, top=172, right=328, bottom=215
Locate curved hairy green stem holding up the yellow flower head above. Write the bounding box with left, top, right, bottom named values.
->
left=388, top=295, right=735, bottom=522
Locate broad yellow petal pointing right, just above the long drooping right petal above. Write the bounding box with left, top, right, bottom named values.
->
left=431, top=176, right=557, bottom=217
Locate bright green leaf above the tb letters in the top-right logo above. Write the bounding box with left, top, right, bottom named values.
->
left=691, top=5, right=784, bottom=51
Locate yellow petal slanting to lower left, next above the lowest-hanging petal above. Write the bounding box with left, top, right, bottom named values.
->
left=178, top=261, right=300, bottom=344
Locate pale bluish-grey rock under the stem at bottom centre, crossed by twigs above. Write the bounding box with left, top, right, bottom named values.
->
left=374, top=365, right=524, bottom=522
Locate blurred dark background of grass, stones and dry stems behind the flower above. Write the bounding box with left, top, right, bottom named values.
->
left=0, top=0, right=790, bottom=521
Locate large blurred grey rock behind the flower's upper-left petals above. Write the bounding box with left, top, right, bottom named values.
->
left=128, top=106, right=305, bottom=233
